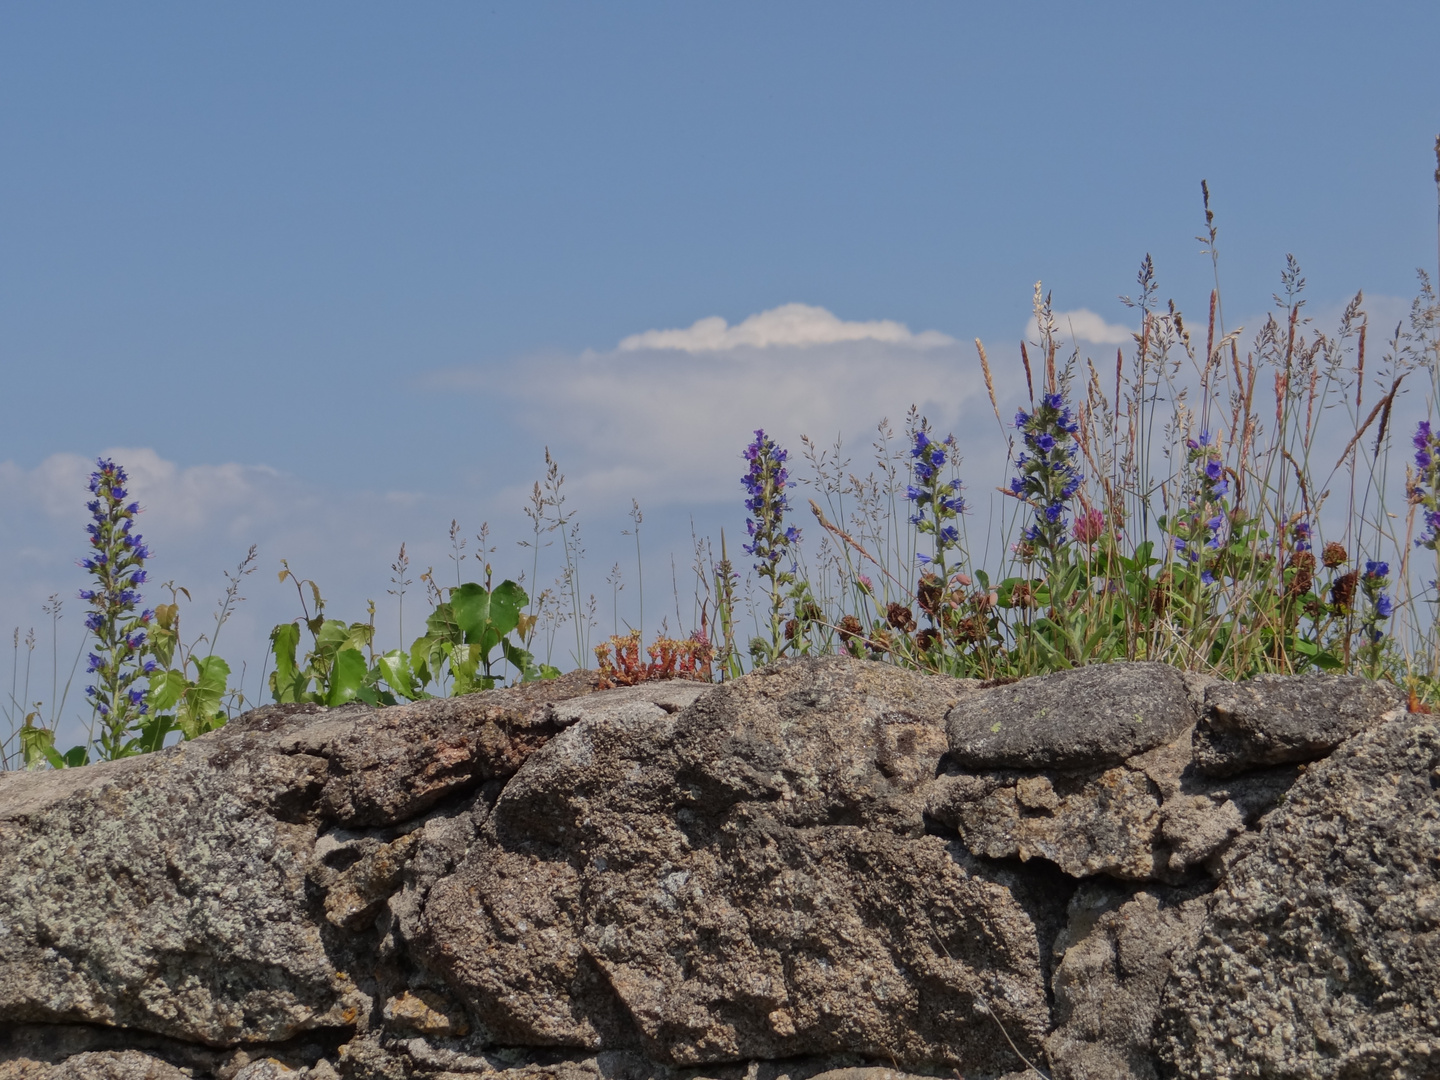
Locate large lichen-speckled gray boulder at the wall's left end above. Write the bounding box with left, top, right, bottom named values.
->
left=0, top=744, right=367, bottom=1044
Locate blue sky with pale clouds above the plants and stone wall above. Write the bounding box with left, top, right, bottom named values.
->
left=0, top=3, right=1440, bottom=722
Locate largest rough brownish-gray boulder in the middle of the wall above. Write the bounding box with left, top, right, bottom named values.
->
left=406, top=658, right=1048, bottom=1076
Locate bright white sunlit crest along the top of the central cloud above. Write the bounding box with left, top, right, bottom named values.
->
left=618, top=304, right=955, bottom=353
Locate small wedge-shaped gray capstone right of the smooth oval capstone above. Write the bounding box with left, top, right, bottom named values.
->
left=1195, top=675, right=1404, bottom=776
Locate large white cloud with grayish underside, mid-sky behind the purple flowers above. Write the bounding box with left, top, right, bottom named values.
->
left=466, top=304, right=1022, bottom=513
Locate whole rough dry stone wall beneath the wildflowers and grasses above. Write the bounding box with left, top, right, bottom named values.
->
left=0, top=658, right=1440, bottom=1080
